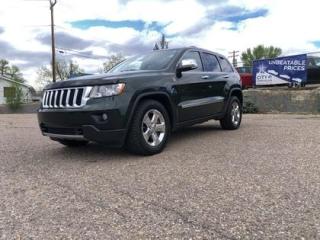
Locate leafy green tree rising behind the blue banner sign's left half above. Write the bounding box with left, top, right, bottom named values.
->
left=241, top=45, right=282, bottom=66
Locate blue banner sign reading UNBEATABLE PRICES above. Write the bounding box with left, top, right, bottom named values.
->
left=252, top=54, right=307, bottom=86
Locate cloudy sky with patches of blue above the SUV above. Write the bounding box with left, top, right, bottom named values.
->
left=0, top=0, right=320, bottom=87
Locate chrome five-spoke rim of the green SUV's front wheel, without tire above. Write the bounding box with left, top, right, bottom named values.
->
left=141, top=109, right=166, bottom=147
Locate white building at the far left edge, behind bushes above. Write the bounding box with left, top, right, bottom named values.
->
left=0, top=75, right=33, bottom=104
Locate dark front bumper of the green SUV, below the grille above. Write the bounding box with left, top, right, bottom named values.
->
left=38, top=109, right=126, bottom=147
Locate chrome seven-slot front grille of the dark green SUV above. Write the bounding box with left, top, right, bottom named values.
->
left=42, top=87, right=92, bottom=108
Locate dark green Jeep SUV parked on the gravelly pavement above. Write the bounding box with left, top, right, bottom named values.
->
left=38, top=47, right=243, bottom=155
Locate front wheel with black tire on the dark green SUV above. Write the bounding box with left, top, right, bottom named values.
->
left=126, top=100, right=171, bottom=155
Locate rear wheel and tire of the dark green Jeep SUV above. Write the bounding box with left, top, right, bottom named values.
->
left=220, top=96, right=242, bottom=130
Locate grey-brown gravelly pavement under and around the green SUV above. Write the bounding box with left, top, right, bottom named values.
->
left=0, top=114, right=320, bottom=240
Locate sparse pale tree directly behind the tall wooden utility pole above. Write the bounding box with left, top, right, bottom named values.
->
left=37, top=60, right=84, bottom=87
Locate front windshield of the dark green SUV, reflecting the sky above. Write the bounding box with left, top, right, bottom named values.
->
left=110, top=50, right=177, bottom=73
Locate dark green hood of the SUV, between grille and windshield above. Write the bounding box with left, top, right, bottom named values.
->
left=44, top=71, right=166, bottom=90
